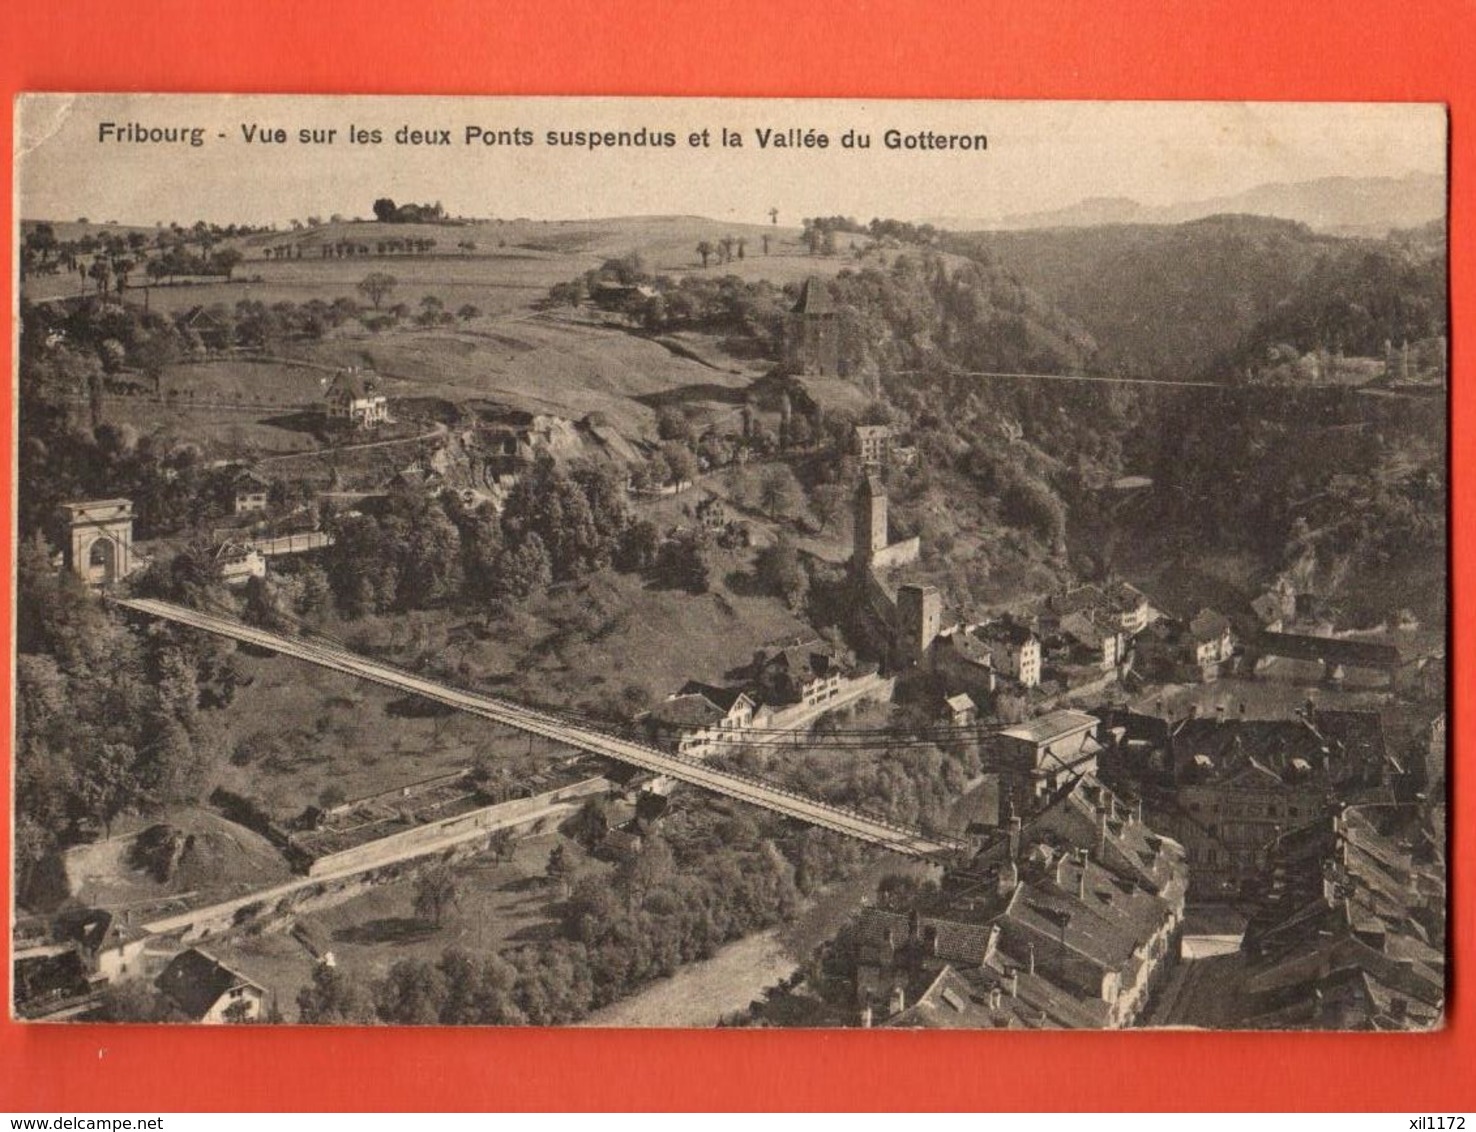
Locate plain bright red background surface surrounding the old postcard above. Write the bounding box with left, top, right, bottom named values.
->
left=0, top=0, right=1476, bottom=1113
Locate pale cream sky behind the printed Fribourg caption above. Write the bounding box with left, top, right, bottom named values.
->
left=16, top=94, right=1446, bottom=226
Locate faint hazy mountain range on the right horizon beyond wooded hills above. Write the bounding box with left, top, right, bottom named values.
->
left=927, top=173, right=1445, bottom=236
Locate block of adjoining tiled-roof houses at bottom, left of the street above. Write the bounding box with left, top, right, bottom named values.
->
left=855, top=776, right=1188, bottom=1029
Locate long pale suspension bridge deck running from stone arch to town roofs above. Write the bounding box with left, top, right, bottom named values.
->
left=115, top=598, right=961, bottom=857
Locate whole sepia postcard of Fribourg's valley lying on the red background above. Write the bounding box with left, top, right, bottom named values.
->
left=10, top=94, right=1451, bottom=1032
